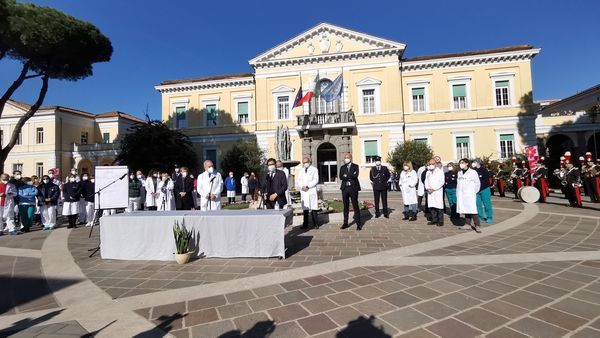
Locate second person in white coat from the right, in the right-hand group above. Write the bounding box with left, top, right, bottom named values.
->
left=425, top=159, right=445, bottom=227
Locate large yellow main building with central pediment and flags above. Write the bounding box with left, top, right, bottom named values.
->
left=155, top=23, right=540, bottom=186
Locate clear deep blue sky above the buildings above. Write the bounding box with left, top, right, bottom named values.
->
left=0, top=0, right=600, bottom=118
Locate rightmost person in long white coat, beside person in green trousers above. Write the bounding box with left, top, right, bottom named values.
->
left=456, top=158, right=481, bottom=233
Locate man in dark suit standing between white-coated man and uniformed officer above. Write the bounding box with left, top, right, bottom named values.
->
left=340, top=153, right=362, bottom=231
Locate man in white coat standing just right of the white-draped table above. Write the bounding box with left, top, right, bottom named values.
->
left=296, top=156, right=319, bottom=229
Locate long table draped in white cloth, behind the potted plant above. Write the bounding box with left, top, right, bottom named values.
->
left=100, top=209, right=293, bottom=261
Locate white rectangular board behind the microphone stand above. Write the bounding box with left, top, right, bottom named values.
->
left=94, top=166, right=129, bottom=209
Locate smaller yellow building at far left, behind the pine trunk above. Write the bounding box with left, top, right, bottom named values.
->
left=0, top=100, right=145, bottom=177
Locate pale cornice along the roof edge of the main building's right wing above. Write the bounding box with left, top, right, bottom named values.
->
left=401, top=48, right=541, bottom=72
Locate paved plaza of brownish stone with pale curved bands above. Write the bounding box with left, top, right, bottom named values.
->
left=0, top=192, right=600, bottom=338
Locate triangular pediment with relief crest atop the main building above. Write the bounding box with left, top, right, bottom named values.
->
left=249, top=23, right=405, bottom=68
